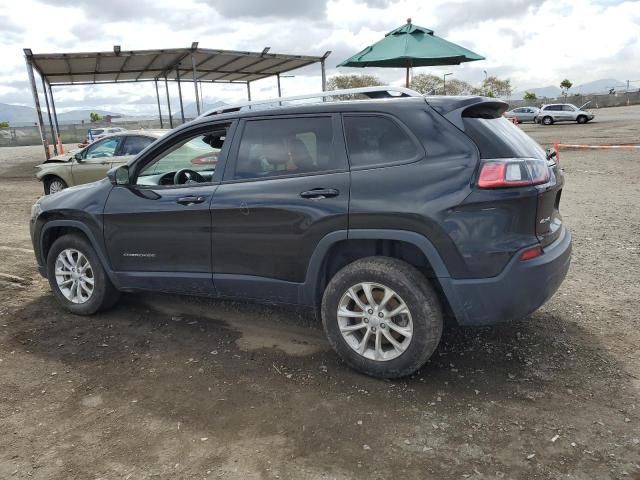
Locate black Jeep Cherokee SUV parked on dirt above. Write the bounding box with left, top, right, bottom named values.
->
left=31, top=88, right=571, bottom=377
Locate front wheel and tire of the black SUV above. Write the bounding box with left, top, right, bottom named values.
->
left=47, top=234, right=120, bottom=315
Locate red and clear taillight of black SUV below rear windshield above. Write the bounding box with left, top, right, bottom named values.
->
left=478, top=159, right=549, bottom=188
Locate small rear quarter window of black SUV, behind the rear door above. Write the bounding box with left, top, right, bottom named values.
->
left=344, top=115, right=418, bottom=168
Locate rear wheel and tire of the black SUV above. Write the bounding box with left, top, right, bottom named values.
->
left=321, top=257, right=443, bottom=378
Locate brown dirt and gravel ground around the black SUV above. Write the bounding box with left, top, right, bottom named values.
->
left=0, top=107, right=640, bottom=480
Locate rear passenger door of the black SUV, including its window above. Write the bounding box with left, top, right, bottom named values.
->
left=211, top=114, right=350, bottom=302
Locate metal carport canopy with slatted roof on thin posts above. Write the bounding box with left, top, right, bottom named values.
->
left=24, top=42, right=331, bottom=158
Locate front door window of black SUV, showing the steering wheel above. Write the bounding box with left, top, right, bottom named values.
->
left=136, top=125, right=229, bottom=185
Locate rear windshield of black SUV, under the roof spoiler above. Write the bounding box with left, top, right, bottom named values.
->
left=462, top=116, right=547, bottom=159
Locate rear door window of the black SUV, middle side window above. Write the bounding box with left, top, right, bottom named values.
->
left=233, top=117, right=341, bottom=179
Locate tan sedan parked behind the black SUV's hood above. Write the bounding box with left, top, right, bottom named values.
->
left=36, top=130, right=168, bottom=195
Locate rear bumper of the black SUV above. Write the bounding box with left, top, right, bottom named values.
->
left=441, top=228, right=571, bottom=325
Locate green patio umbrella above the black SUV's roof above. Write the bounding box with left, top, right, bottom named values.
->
left=338, top=18, right=484, bottom=87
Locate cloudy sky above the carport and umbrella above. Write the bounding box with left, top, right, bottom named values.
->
left=0, top=0, right=640, bottom=114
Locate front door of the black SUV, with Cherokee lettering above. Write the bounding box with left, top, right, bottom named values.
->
left=104, top=122, right=232, bottom=293
